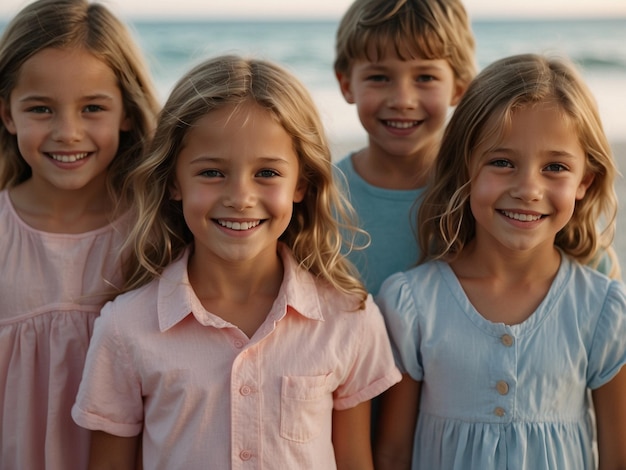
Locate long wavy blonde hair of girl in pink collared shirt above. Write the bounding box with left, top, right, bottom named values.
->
left=125, top=55, right=367, bottom=307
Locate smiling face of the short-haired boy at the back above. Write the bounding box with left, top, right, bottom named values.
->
left=337, top=47, right=463, bottom=162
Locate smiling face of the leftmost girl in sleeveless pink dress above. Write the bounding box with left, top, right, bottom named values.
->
left=2, top=48, right=131, bottom=190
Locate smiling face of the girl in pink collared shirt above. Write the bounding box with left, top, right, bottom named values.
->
left=172, top=99, right=306, bottom=263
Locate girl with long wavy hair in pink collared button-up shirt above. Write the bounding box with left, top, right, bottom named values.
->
left=73, top=56, right=400, bottom=470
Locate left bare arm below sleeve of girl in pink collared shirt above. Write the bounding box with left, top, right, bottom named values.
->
left=89, top=431, right=141, bottom=470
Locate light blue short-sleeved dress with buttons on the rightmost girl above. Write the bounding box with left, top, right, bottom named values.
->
left=377, top=255, right=626, bottom=470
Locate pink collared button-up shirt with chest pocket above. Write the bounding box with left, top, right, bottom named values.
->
left=72, top=245, right=400, bottom=470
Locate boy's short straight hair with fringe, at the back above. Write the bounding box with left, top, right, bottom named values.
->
left=334, top=0, right=476, bottom=86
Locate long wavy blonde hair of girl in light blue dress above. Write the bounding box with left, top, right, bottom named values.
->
left=418, top=54, right=620, bottom=278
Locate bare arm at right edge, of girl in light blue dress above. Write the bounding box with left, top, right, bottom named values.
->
left=593, top=366, right=626, bottom=470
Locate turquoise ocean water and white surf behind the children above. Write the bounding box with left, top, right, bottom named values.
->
left=118, top=18, right=626, bottom=149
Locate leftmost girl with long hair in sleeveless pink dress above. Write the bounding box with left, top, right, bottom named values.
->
left=0, top=0, right=158, bottom=470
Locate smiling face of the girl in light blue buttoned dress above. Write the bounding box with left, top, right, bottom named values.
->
left=470, top=103, right=593, bottom=254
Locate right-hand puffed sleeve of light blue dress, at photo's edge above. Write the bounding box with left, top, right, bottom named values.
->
left=587, top=281, right=626, bottom=389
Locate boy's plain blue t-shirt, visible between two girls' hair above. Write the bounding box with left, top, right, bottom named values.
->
left=337, top=155, right=424, bottom=295
